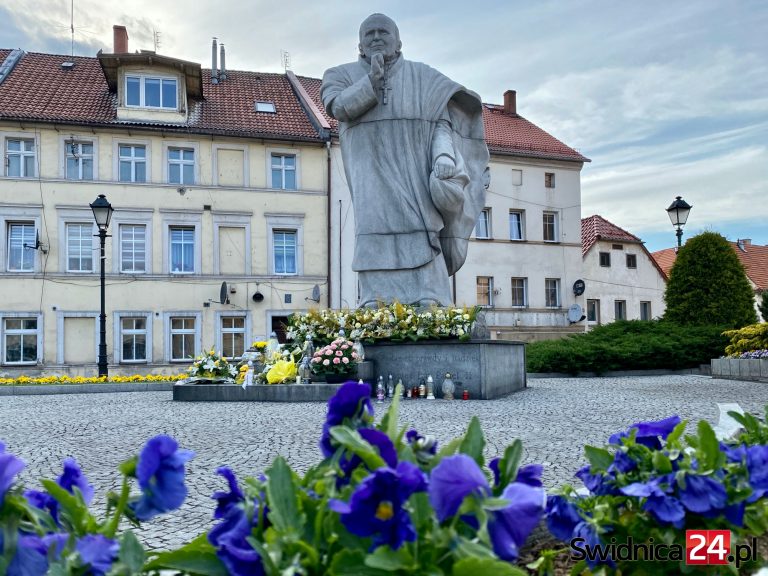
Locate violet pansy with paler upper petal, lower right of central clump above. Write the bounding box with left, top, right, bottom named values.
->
left=488, top=482, right=546, bottom=562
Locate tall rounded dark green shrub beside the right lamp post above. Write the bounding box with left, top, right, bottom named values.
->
left=664, top=232, right=757, bottom=328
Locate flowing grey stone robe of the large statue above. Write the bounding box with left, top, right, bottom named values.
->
left=320, top=56, right=489, bottom=305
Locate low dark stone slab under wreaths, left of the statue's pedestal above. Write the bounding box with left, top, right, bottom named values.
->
left=173, top=382, right=342, bottom=402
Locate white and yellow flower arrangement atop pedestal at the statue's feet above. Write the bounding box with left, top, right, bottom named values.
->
left=287, top=302, right=478, bottom=342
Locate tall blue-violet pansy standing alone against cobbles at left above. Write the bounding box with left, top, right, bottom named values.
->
left=130, top=435, right=194, bottom=520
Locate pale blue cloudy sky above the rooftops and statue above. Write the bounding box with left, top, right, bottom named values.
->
left=0, top=0, right=768, bottom=250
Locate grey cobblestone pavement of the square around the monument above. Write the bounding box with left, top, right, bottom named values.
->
left=0, top=376, right=768, bottom=549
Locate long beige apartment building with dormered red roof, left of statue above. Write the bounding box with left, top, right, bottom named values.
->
left=0, top=27, right=329, bottom=375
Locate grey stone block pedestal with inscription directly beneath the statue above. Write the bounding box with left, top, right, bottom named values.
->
left=365, top=340, right=526, bottom=400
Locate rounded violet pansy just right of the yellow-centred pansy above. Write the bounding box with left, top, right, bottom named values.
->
left=429, top=454, right=490, bottom=522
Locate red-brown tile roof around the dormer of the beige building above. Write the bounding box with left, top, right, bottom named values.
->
left=0, top=50, right=322, bottom=141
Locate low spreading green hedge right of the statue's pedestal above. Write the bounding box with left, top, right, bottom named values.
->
left=526, top=320, right=728, bottom=374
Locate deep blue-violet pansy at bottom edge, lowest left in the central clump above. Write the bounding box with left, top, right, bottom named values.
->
left=208, top=505, right=264, bottom=576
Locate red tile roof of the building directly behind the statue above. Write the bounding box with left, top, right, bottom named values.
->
left=298, top=76, right=589, bottom=162
